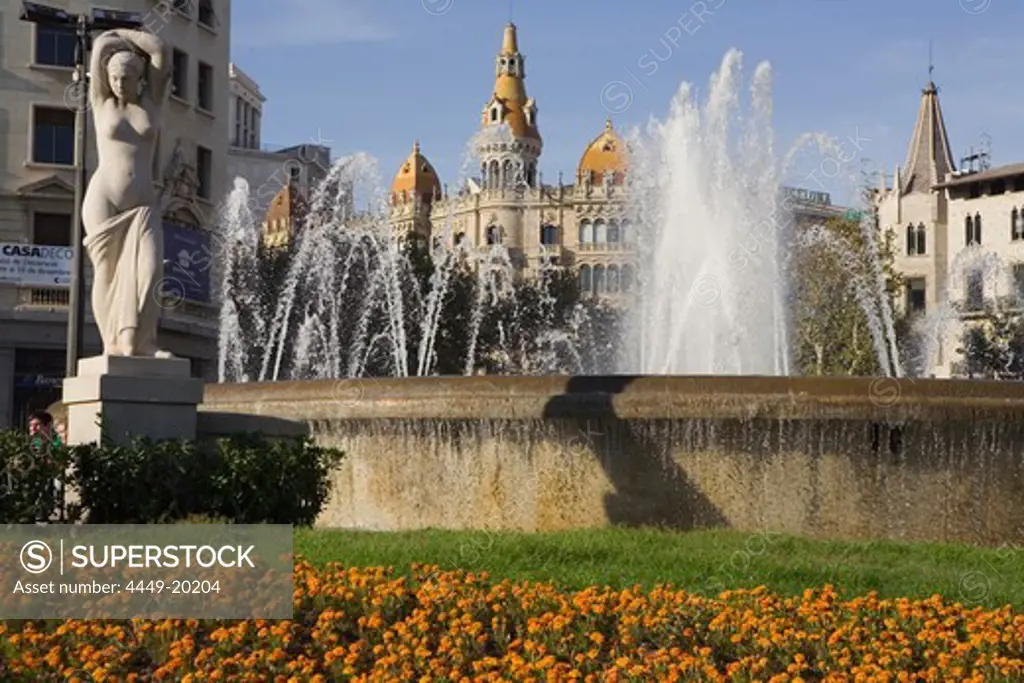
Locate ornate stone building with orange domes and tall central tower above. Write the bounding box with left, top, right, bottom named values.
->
left=389, top=24, right=842, bottom=301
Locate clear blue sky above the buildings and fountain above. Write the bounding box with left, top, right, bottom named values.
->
left=231, top=0, right=1024, bottom=208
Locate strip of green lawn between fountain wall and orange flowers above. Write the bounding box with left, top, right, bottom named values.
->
left=295, top=529, right=1024, bottom=610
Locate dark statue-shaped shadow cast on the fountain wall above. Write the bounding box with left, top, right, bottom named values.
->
left=544, top=376, right=729, bottom=530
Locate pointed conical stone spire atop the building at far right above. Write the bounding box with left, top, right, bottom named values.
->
left=897, top=80, right=956, bottom=195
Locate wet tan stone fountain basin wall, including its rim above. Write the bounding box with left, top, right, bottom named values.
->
left=200, top=376, right=1024, bottom=545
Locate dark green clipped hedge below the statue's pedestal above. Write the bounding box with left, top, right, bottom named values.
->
left=0, top=432, right=343, bottom=526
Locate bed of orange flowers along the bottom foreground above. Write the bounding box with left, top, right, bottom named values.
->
left=0, top=562, right=1024, bottom=683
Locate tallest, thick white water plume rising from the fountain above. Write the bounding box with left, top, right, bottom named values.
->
left=631, top=50, right=790, bottom=375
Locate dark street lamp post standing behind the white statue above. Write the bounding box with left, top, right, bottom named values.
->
left=20, top=2, right=142, bottom=377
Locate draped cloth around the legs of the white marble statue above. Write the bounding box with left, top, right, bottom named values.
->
left=83, top=206, right=164, bottom=348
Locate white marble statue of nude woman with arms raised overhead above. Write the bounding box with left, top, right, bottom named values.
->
left=82, top=29, right=172, bottom=357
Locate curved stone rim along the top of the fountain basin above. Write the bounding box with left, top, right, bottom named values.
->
left=200, top=376, right=1024, bottom=423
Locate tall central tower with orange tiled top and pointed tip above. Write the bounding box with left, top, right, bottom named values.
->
left=477, top=24, right=542, bottom=189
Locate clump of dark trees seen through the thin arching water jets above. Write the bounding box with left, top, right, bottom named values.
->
left=229, top=224, right=621, bottom=380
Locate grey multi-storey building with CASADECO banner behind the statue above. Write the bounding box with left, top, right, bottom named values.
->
left=0, top=0, right=231, bottom=429
